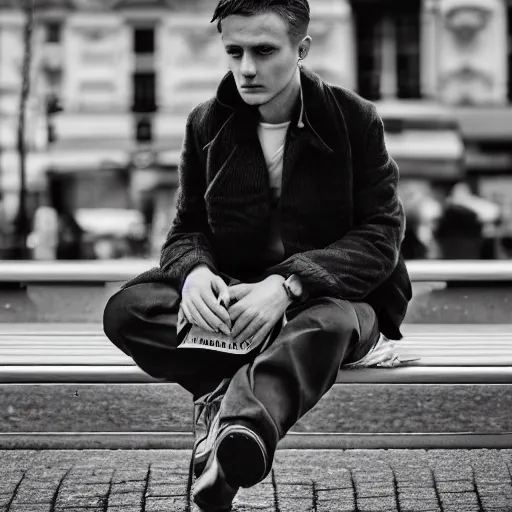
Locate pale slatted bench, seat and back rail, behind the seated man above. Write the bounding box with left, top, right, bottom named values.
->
left=0, top=260, right=512, bottom=383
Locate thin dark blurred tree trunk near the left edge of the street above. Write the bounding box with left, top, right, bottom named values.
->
left=12, top=0, right=34, bottom=259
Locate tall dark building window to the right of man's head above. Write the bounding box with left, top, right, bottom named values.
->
left=353, top=0, right=421, bottom=100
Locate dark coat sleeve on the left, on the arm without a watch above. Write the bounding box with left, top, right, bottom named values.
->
left=160, top=108, right=217, bottom=292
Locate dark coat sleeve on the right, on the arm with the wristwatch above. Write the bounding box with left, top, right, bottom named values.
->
left=266, top=105, right=405, bottom=301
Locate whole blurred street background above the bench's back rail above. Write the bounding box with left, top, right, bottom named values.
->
left=0, top=0, right=512, bottom=260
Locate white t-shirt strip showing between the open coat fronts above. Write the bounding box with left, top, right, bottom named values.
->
left=258, top=121, right=290, bottom=260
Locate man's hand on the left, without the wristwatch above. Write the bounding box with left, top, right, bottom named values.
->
left=181, top=265, right=231, bottom=335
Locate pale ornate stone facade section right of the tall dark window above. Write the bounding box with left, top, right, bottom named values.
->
left=423, top=0, right=508, bottom=105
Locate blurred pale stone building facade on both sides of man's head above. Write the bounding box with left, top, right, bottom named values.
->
left=0, top=0, right=507, bottom=196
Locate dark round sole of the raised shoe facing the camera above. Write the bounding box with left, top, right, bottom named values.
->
left=217, top=425, right=267, bottom=487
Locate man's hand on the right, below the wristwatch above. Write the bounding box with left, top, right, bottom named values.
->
left=228, top=275, right=291, bottom=344
